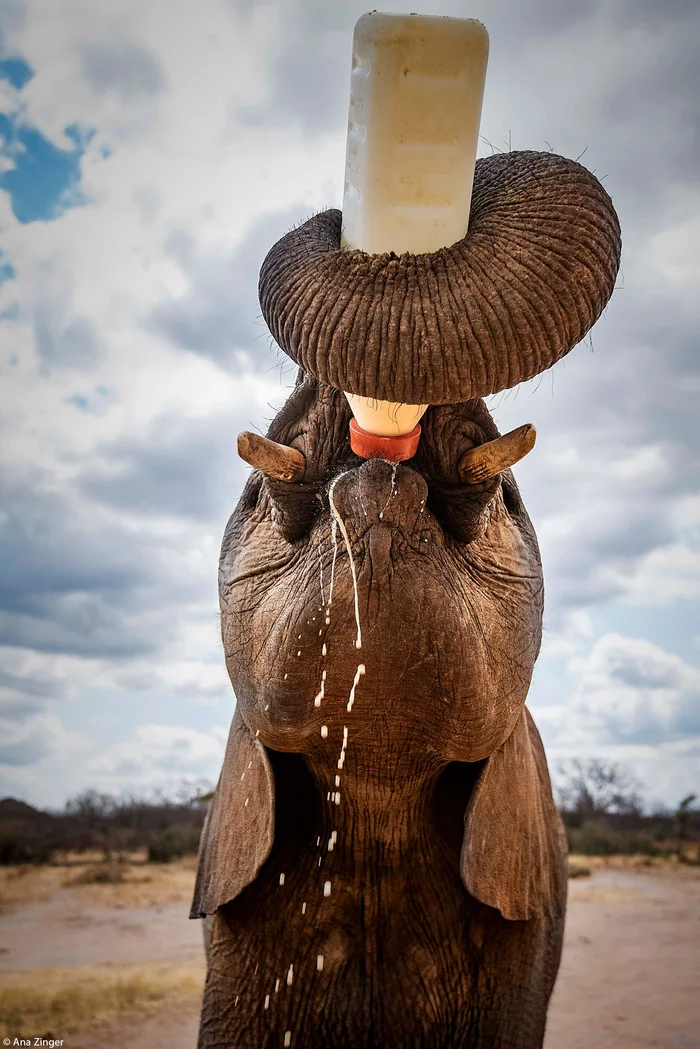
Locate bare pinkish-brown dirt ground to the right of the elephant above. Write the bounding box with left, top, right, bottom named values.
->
left=545, top=870, right=700, bottom=1049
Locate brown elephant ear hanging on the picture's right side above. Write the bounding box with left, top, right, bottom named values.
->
left=461, top=708, right=567, bottom=921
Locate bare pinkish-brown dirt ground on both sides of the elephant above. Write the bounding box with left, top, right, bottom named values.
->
left=0, top=865, right=700, bottom=1049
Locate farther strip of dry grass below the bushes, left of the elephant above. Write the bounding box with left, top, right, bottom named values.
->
left=0, top=856, right=196, bottom=909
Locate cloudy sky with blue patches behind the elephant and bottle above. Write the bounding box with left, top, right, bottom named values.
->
left=0, top=0, right=700, bottom=806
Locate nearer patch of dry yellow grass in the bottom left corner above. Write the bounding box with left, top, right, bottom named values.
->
left=0, top=965, right=203, bottom=1039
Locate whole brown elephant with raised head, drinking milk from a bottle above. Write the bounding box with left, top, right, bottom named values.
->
left=192, top=152, right=620, bottom=1049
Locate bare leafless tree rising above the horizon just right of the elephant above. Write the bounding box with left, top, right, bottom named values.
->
left=557, top=757, right=642, bottom=822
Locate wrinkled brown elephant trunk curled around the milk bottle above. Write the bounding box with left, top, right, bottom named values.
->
left=259, top=151, right=620, bottom=404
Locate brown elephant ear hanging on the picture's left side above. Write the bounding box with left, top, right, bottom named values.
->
left=190, top=708, right=275, bottom=918
